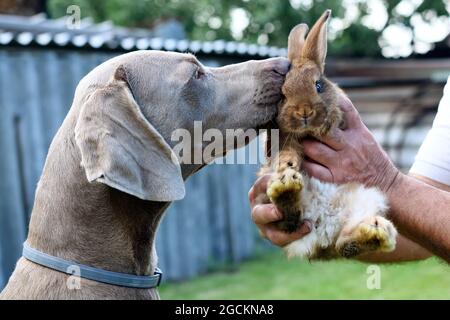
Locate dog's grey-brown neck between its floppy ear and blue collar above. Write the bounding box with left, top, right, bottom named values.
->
left=27, top=126, right=169, bottom=275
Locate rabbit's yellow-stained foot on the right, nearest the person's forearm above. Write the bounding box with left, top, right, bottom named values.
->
left=336, top=216, right=397, bottom=258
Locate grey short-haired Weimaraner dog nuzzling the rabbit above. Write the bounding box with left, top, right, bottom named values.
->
left=0, top=51, right=289, bottom=299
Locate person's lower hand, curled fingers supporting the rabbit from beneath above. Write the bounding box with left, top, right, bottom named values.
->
left=248, top=174, right=312, bottom=247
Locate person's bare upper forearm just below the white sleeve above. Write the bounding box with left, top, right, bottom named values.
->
left=388, top=174, right=450, bottom=262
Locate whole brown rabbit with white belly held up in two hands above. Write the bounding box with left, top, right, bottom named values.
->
left=261, top=10, right=397, bottom=259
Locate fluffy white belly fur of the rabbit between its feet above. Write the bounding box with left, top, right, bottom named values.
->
left=284, top=174, right=388, bottom=258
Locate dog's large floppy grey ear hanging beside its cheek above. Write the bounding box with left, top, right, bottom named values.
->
left=75, top=66, right=185, bottom=201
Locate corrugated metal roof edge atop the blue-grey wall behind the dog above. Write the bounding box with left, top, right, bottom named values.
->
left=0, top=14, right=287, bottom=57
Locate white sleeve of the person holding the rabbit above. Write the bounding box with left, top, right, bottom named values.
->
left=410, top=76, right=450, bottom=185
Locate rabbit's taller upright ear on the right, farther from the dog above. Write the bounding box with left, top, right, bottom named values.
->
left=302, top=10, right=331, bottom=72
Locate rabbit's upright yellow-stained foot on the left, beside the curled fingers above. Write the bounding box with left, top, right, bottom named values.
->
left=267, top=168, right=303, bottom=232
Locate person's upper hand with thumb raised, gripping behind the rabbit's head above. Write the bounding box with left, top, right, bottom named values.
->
left=303, top=95, right=399, bottom=192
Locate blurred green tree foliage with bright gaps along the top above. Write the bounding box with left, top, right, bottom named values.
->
left=48, top=0, right=450, bottom=56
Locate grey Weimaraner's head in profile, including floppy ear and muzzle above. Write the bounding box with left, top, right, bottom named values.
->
left=74, top=51, right=290, bottom=201
